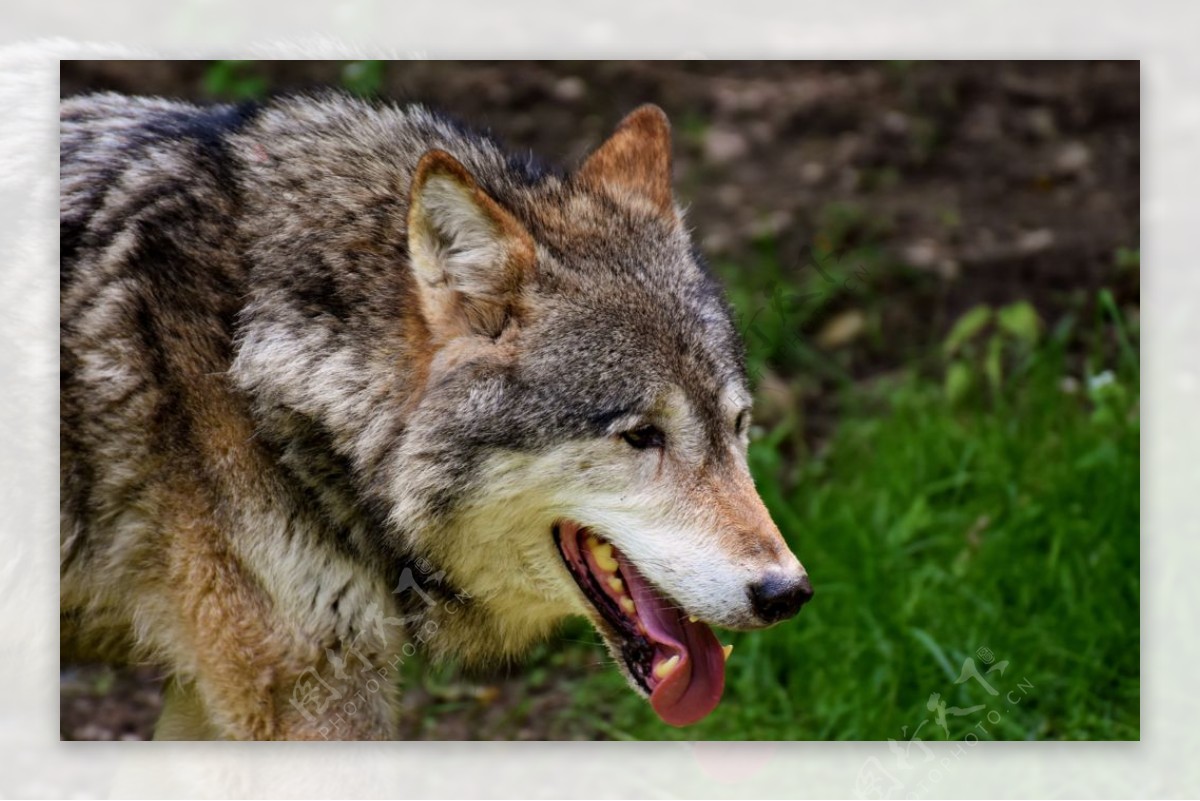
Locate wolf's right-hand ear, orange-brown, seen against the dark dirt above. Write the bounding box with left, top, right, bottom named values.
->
left=578, top=103, right=676, bottom=219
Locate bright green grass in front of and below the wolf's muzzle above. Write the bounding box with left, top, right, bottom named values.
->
left=549, top=326, right=1139, bottom=740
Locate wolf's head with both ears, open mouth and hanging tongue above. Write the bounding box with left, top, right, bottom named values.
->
left=390, top=106, right=812, bottom=724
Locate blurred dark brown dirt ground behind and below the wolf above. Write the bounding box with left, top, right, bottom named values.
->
left=61, top=61, right=1140, bottom=739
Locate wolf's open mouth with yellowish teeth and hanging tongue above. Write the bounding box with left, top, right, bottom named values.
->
left=554, top=522, right=732, bottom=725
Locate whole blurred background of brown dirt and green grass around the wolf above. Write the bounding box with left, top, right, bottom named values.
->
left=60, top=61, right=1140, bottom=743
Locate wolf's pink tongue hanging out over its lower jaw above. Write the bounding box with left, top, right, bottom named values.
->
left=622, top=564, right=725, bottom=725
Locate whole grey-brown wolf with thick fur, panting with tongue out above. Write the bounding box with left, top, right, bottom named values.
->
left=60, top=92, right=812, bottom=740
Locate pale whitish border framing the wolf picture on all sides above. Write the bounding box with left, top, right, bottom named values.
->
left=0, top=0, right=1200, bottom=797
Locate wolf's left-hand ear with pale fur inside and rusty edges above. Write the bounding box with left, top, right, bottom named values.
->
left=408, top=150, right=534, bottom=339
